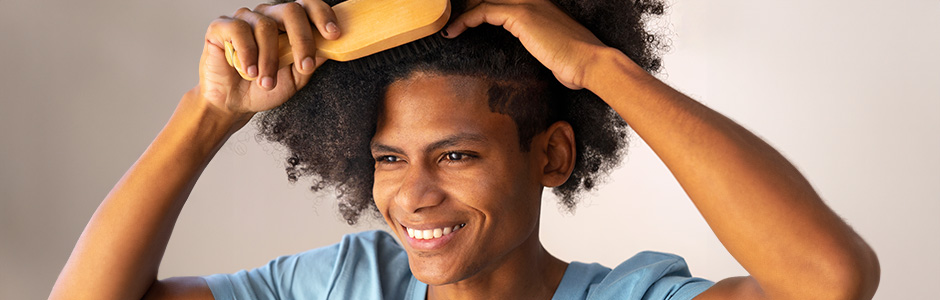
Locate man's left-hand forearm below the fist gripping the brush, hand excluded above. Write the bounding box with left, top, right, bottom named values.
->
left=50, top=88, right=245, bottom=299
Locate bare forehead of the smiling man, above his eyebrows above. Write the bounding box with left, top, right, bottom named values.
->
left=373, top=73, right=515, bottom=145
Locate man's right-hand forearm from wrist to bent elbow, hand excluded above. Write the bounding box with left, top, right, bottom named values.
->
left=586, top=48, right=878, bottom=298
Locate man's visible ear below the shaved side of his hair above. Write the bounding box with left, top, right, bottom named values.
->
left=539, top=121, right=577, bottom=187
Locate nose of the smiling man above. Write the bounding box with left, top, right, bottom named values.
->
left=395, top=164, right=445, bottom=213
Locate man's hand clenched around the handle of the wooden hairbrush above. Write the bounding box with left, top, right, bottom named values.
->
left=197, top=0, right=340, bottom=119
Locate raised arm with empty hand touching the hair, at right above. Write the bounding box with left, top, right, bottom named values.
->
left=446, top=0, right=880, bottom=299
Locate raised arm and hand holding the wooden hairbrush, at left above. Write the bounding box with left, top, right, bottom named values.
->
left=49, top=0, right=339, bottom=299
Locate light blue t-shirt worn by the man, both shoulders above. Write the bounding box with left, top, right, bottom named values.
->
left=203, top=230, right=713, bottom=300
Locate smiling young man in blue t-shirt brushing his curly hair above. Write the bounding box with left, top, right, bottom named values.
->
left=51, top=0, right=879, bottom=299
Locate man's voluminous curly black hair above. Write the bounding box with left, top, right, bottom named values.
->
left=257, top=0, right=664, bottom=224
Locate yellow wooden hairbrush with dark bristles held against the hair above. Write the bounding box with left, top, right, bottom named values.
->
left=225, top=0, right=450, bottom=80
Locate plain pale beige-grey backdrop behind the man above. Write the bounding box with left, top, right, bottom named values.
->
left=0, top=0, right=940, bottom=299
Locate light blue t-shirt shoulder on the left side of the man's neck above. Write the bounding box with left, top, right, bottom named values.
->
left=205, top=230, right=412, bottom=299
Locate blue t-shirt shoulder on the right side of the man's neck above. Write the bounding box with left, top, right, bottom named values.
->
left=559, top=251, right=713, bottom=299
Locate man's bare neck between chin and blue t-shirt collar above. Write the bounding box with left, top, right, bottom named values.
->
left=427, top=230, right=568, bottom=300
